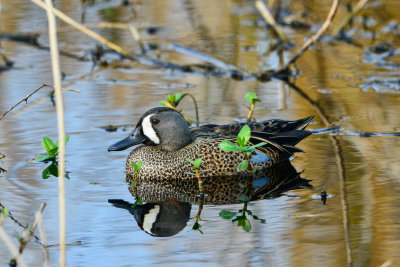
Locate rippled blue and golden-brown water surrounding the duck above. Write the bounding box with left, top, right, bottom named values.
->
left=0, top=0, right=400, bottom=266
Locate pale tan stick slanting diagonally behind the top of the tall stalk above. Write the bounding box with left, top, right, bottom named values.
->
left=31, top=0, right=129, bottom=57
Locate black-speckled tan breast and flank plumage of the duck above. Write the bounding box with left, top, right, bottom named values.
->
left=126, top=137, right=278, bottom=180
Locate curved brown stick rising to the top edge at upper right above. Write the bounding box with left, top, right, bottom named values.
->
left=276, top=0, right=340, bottom=72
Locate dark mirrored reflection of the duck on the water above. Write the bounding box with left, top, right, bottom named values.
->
left=109, top=160, right=310, bottom=237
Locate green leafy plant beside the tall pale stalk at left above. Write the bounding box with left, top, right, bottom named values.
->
left=35, top=135, right=69, bottom=179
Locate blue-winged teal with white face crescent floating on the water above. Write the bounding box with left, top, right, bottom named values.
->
left=108, top=107, right=314, bottom=180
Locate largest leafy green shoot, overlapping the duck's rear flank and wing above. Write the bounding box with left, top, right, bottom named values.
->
left=219, top=124, right=266, bottom=174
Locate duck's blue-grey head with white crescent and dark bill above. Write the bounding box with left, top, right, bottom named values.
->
left=108, top=107, right=191, bottom=151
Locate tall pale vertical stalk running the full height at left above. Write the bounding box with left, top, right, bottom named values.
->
left=43, top=0, right=66, bottom=267
